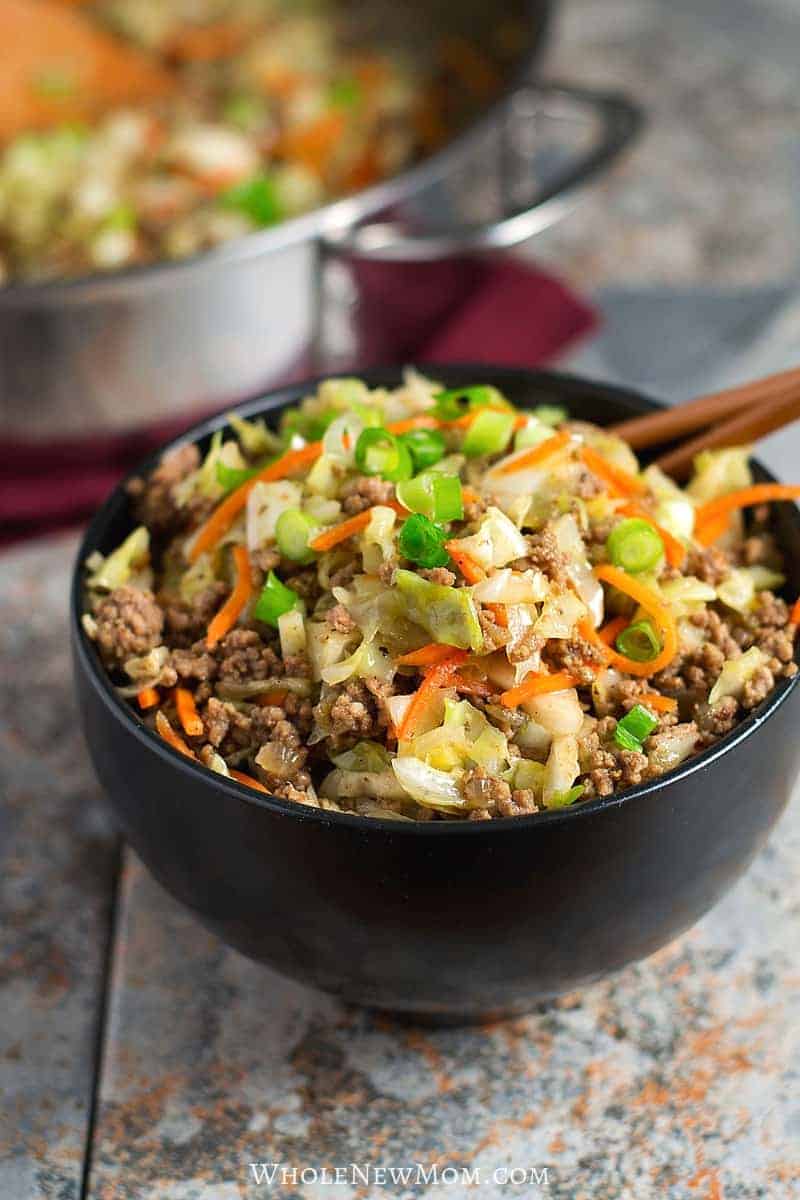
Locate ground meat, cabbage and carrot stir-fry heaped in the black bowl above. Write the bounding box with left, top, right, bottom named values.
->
left=83, top=371, right=800, bottom=821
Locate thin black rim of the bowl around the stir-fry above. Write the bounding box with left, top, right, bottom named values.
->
left=70, top=362, right=800, bottom=836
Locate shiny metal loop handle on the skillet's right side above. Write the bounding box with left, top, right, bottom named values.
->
left=323, top=83, right=644, bottom=262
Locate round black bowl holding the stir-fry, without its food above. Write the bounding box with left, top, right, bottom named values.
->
left=71, top=366, right=800, bottom=1020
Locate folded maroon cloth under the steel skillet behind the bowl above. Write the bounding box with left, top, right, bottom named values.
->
left=0, top=258, right=596, bottom=546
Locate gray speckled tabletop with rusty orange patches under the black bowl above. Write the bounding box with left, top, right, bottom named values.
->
left=0, top=0, right=800, bottom=1200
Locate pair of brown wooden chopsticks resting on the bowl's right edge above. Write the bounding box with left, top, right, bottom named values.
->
left=613, top=368, right=800, bottom=479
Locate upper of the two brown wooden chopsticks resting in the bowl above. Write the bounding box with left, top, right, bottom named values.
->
left=612, top=368, right=800, bottom=450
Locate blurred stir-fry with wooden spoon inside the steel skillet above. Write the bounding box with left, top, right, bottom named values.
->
left=0, top=0, right=450, bottom=282
